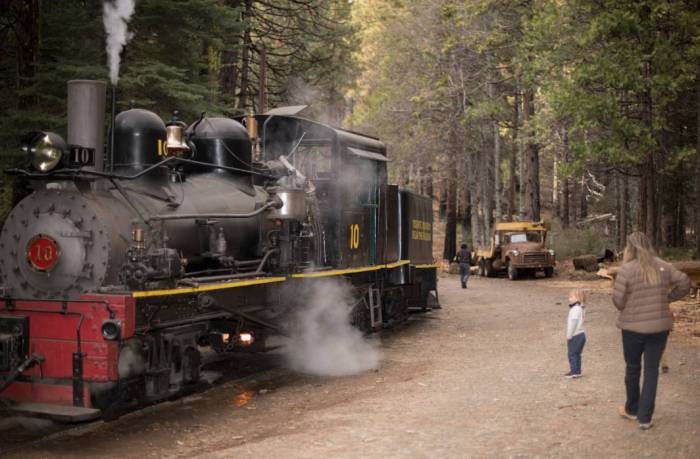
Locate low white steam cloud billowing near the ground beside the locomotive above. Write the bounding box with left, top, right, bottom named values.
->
left=283, top=280, right=380, bottom=376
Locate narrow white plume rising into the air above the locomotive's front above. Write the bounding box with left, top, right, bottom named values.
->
left=102, top=0, right=134, bottom=85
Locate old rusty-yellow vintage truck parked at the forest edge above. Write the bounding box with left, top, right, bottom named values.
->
left=476, top=221, right=556, bottom=280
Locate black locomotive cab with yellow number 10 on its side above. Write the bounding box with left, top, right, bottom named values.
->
left=250, top=115, right=395, bottom=268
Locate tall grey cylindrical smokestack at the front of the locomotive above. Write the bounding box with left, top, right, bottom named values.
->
left=68, top=80, right=107, bottom=172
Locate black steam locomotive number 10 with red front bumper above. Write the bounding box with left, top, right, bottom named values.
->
left=0, top=80, right=439, bottom=422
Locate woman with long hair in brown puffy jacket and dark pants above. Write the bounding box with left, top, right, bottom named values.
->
left=613, top=232, right=690, bottom=430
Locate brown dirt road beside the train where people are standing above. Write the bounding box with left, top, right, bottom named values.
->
left=0, top=276, right=700, bottom=459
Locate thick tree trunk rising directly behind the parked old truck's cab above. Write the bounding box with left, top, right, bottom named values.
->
left=523, top=88, right=540, bottom=221
